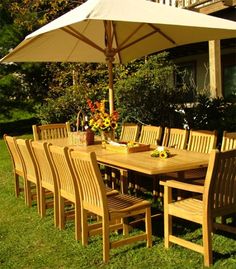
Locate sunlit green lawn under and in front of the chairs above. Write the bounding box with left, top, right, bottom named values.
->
left=0, top=136, right=236, bottom=269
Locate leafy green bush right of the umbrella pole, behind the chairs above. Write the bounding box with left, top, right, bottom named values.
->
left=115, top=53, right=185, bottom=127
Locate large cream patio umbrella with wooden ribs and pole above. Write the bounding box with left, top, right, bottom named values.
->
left=1, top=0, right=236, bottom=112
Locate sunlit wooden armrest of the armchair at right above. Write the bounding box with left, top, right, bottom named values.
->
left=160, top=179, right=204, bottom=193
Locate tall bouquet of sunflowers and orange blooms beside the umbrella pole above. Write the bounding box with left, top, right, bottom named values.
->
left=87, top=99, right=119, bottom=132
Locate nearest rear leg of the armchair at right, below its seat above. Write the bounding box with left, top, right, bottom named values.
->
left=202, top=218, right=213, bottom=267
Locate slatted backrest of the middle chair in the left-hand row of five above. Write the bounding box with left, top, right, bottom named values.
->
left=31, top=141, right=57, bottom=191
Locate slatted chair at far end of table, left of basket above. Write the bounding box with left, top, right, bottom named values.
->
left=32, top=122, right=70, bottom=141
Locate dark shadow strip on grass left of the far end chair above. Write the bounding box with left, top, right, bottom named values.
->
left=0, top=118, right=38, bottom=137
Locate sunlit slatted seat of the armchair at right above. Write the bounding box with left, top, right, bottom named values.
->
left=168, top=196, right=203, bottom=224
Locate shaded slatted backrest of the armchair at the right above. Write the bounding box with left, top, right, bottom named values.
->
left=205, top=149, right=236, bottom=217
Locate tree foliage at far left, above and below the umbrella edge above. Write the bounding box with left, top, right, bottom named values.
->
left=0, top=0, right=86, bottom=116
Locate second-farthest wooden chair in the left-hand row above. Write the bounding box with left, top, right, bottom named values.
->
left=16, top=139, right=40, bottom=211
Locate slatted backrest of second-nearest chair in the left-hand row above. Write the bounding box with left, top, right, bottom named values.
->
left=48, top=145, right=77, bottom=201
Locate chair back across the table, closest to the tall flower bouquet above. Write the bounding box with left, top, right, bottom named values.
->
left=119, top=123, right=139, bottom=142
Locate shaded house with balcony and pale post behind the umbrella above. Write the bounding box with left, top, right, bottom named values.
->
left=154, top=0, right=236, bottom=98
